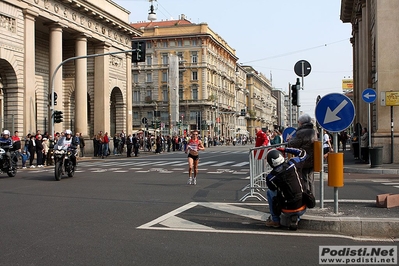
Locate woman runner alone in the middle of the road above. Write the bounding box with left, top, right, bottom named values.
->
left=185, top=130, right=205, bottom=185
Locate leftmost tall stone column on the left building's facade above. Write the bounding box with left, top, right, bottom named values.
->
left=22, top=9, right=39, bottom=136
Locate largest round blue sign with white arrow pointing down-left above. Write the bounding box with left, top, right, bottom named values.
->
left=315, top=93, right=355, bottom=132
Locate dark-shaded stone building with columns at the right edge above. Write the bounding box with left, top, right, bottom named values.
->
left=341, top=0, right=399, bottom=163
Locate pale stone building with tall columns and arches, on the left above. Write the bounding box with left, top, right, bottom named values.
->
left=0, top=0, right=141, bottom=140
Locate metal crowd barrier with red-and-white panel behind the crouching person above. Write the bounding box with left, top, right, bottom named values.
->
left=240, top=143, right=287, bottom=201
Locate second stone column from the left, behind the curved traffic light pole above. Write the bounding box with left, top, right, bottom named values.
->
left=49, top=24, right=65, bottom=134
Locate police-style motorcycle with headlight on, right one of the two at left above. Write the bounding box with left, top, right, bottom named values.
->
left=54, top=140, right=76, bottom=181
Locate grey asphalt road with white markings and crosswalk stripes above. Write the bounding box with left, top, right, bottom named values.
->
left=0, top=146, right=399, bottom=265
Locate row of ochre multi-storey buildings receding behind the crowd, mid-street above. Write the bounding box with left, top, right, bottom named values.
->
left=131, top=15, right=276, bottom=137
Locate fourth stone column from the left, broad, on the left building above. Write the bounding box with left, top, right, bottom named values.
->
left=94, top=42, right=111, bottom=134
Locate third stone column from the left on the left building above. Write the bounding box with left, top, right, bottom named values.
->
left=74, top=35, right=88, bottom=136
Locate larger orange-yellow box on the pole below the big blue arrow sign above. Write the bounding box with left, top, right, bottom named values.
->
left=328, top=152, right=344, bottom=187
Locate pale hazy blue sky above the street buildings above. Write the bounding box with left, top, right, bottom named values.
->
left=114, top=0, right=352, bottom=117
